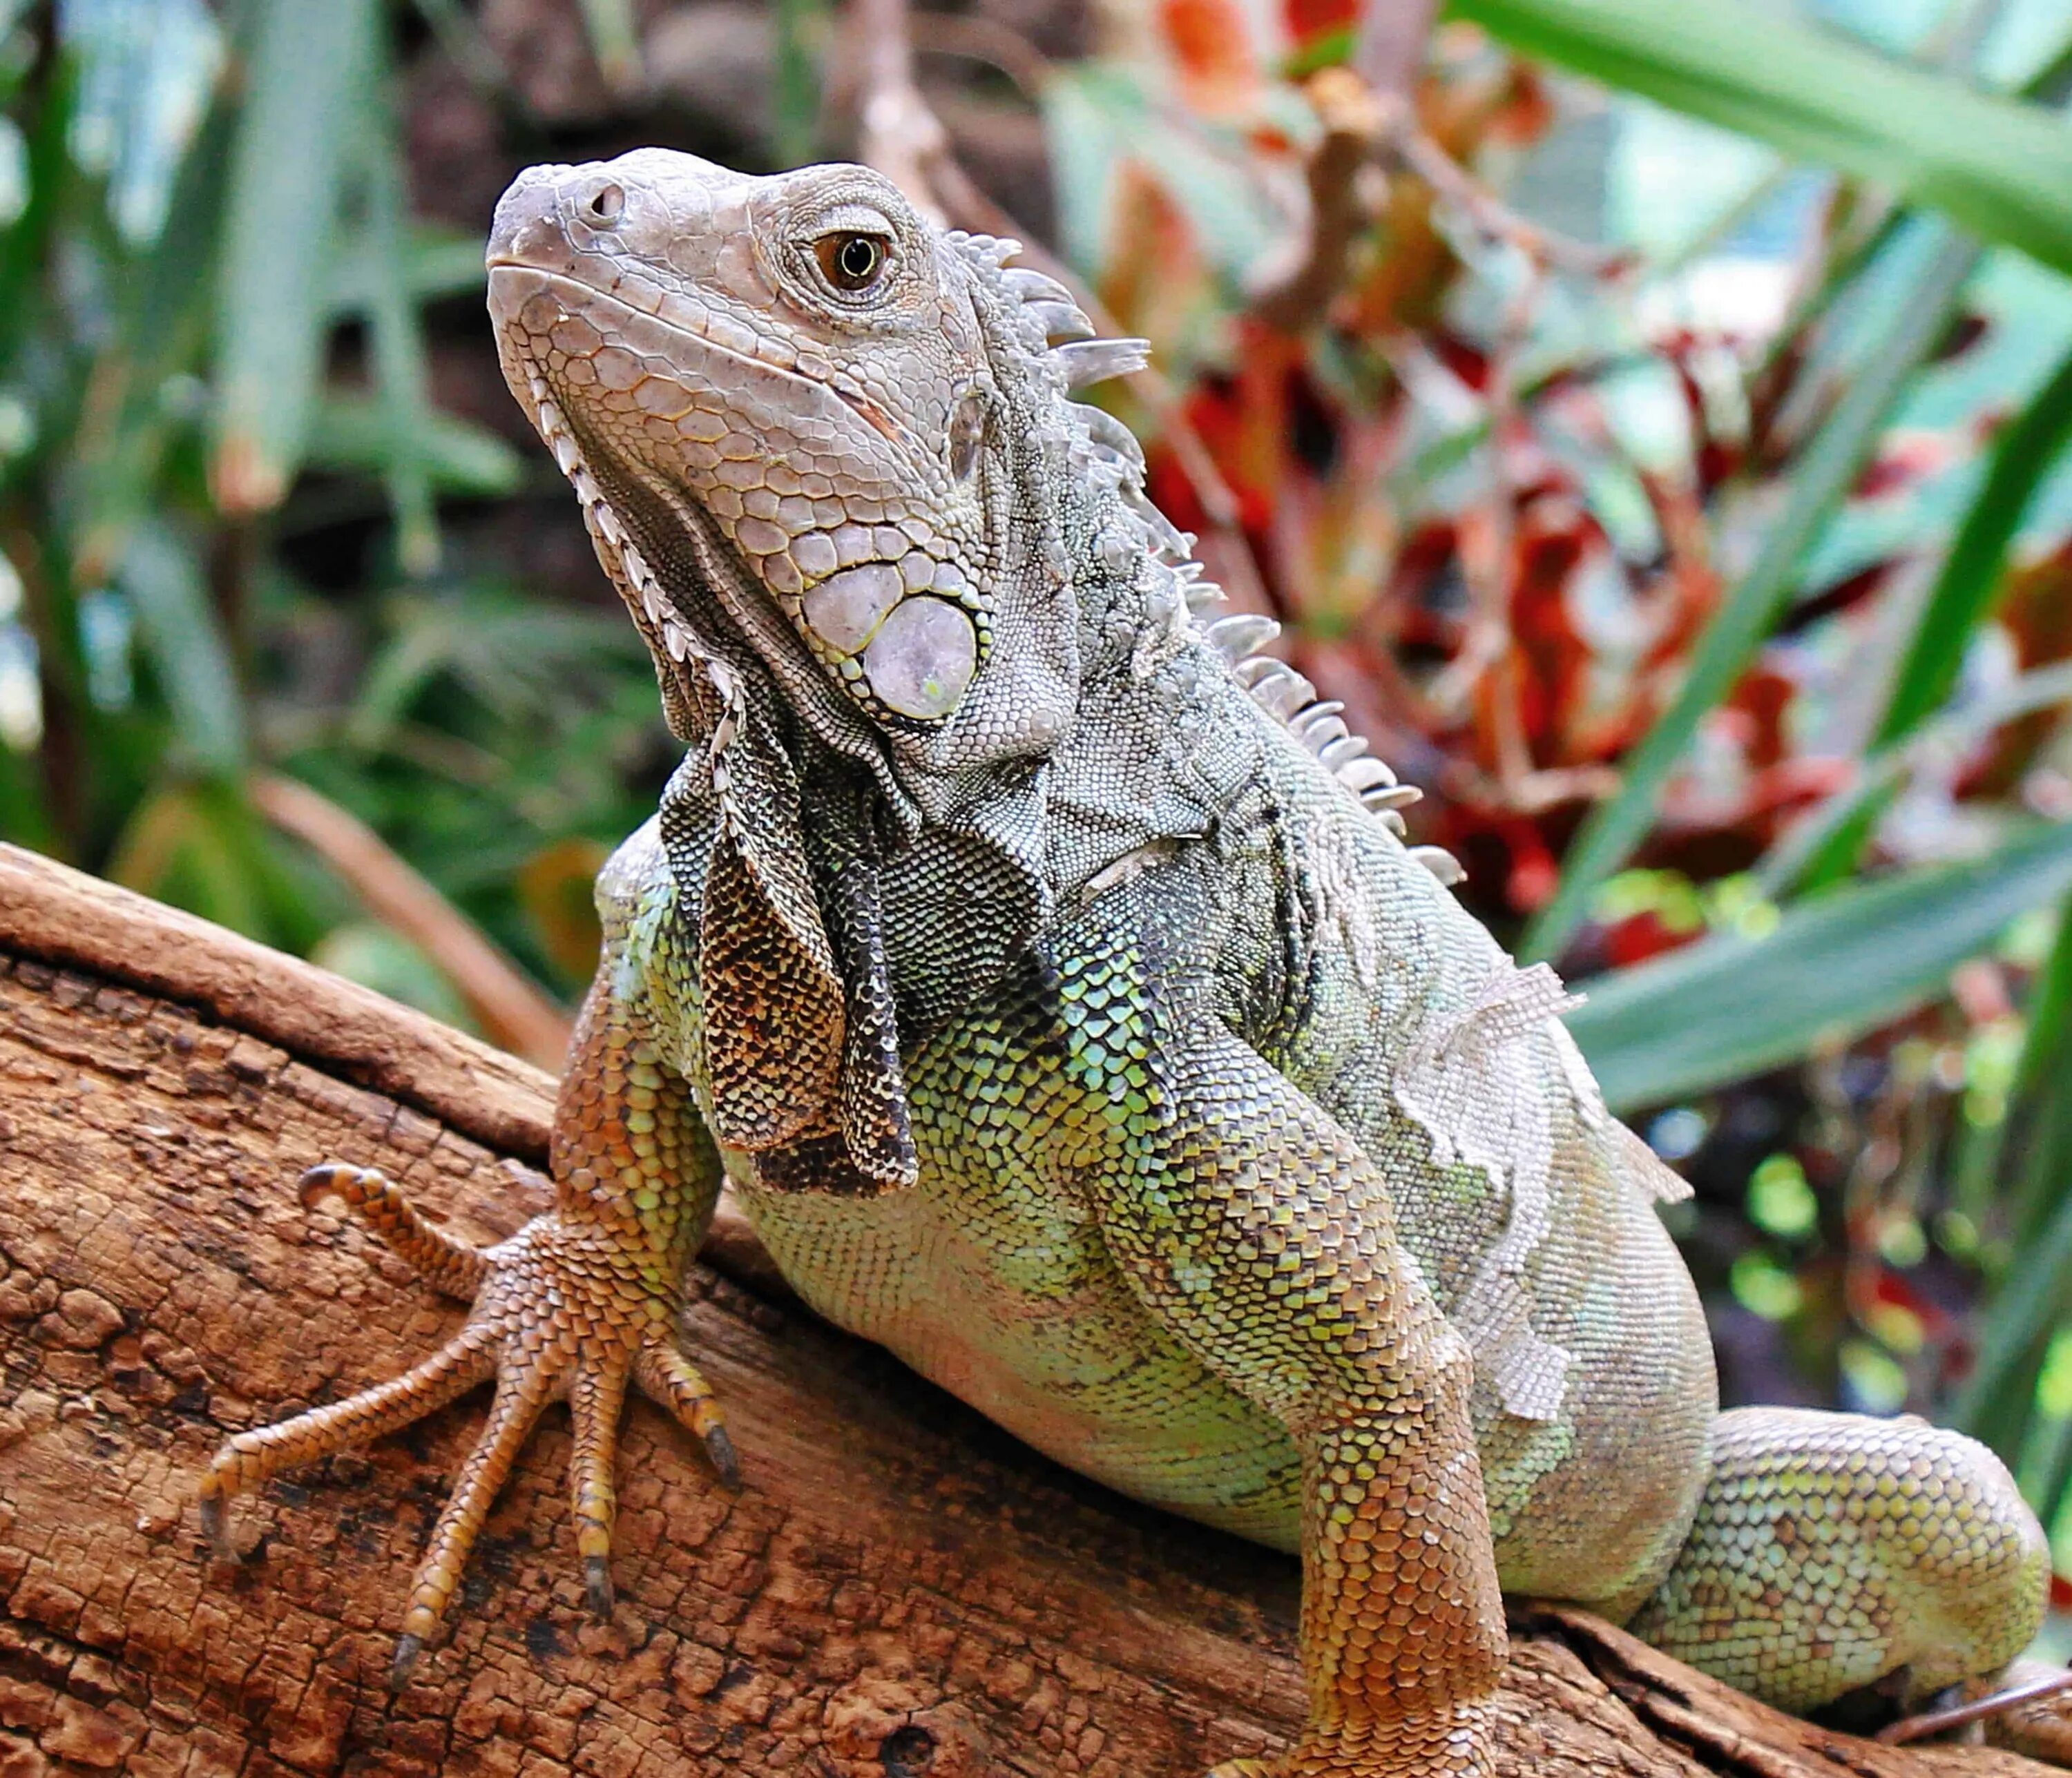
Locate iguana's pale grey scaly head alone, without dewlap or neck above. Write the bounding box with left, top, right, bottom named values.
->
left=489, top=149, right=1142, bottom=804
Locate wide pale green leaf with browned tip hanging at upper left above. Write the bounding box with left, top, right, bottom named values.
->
left=209, top=0, right=381, bottom=512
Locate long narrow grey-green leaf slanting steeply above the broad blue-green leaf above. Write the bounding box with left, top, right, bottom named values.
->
left=1519, top=230, right=1979, bottom=958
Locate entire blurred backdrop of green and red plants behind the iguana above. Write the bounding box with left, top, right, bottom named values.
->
left=0, top=0, right=2072, bottom=1624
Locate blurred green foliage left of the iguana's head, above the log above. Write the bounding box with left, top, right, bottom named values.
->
left=0, top=0, right=659, bottom=1014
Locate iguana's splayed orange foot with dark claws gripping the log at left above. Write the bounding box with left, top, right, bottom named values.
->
left=189, top=1163, right=738, bottom=1687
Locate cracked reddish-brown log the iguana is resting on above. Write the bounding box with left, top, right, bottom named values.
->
left=0, top=847, right=2043, bottom=1778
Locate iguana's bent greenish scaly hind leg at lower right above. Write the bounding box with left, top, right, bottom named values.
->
left=1629, top=1407, right=2049, bottom=1714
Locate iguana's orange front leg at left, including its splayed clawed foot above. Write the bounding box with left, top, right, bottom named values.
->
left=201, top=958, right=733, bottom=1685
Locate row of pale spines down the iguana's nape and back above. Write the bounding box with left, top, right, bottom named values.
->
left=949, top=232, right=1465, bottom=885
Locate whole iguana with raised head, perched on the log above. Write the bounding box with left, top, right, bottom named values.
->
left=201, top=149, right=2049, bottom=1778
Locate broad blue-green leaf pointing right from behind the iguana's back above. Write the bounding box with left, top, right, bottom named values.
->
left=1569, top=822, right=2072, bottom=1111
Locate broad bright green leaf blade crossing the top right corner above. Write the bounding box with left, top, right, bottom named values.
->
left=1446, top=0, right=2072, bottom=271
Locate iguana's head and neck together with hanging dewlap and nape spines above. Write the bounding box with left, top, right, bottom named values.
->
left=489, top=149, right=1442, bottom=1190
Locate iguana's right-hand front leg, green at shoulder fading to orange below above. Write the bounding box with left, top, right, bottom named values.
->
left=1055, top=907, right=1504, bottom=1778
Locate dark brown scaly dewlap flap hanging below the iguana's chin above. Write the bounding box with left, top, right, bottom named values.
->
left=698, top=679, right=918, bottom=1194
